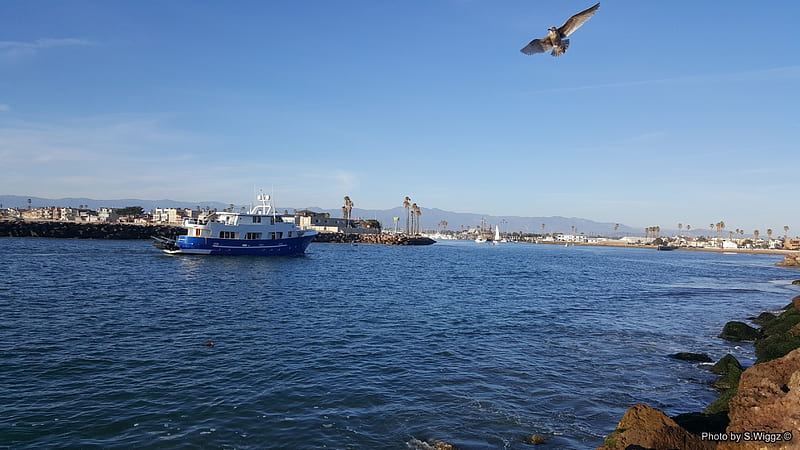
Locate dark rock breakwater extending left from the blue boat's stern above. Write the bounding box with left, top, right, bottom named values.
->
left=0, top=221, right=184, bottom=240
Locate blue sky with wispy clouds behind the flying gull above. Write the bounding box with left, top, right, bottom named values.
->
left=0, top=0, right=800, bottom=234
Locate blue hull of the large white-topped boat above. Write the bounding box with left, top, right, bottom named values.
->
left=169, top=233, right=316, bottom=256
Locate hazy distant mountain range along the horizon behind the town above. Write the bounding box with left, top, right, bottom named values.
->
left=0, top=195, right=680, bottom=236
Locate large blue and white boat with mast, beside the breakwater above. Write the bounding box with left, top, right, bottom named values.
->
left=153, top=194, right=317, bottom=256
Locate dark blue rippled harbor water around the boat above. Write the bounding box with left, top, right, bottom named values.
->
left=0, top=238, right=800, bottom=449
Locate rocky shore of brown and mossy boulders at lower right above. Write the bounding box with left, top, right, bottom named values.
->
left=598, top=296, right=800, bottom=450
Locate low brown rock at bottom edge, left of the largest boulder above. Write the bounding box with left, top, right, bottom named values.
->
left=598, top=404, right=716, bottom=450
